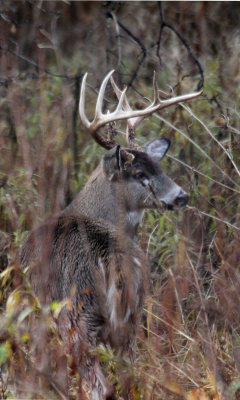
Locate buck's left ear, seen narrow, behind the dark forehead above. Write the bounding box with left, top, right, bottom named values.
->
left=102, top=146, right=121, bottom=181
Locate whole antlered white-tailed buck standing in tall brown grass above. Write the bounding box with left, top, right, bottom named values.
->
left=21, top=71, right=200, bottom=400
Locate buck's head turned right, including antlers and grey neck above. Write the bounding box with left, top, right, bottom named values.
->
left=66, top=71, right=201, bottom=234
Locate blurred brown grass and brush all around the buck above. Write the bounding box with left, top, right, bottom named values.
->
left=0, top=0, right=240, bottom=400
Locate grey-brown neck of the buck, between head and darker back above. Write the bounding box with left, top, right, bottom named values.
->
left=63, top=167, right=144, bottom=238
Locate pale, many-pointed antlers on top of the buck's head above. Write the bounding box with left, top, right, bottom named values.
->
left=79, top=70, right=202, bottom=149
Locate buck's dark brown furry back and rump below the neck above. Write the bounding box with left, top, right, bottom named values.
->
left=21, top=216, right=146, bottom=348
